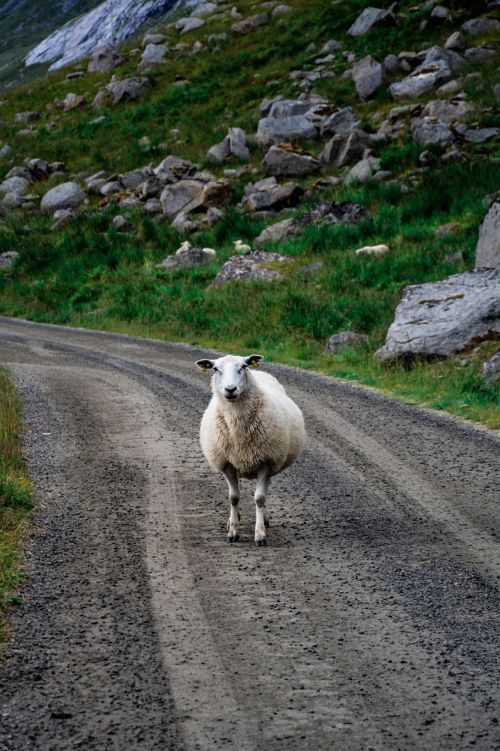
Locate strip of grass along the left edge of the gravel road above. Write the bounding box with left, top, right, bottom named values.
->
left=0, top=368, right=32, bottom=653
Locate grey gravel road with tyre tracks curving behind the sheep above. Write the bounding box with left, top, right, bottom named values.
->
left=0, top=318, right=500, bottom=751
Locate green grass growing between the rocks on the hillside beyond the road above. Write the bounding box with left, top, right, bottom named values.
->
left=0, top=0, right=500, bottom=426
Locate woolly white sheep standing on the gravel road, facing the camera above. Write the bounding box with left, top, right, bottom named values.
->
left=196, top=355, right=305, bottom=546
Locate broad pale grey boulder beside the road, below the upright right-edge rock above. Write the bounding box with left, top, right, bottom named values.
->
left=376, top=269, right=500, bottom=361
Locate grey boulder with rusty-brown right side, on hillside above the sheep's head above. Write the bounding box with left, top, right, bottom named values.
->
left=160, top=180, right=232, bottom=219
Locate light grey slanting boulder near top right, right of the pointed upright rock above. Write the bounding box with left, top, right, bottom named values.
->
left=389, top=46, right=465, bottom=99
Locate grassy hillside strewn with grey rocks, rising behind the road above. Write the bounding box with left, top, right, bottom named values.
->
left=0, top=0, right=500, bottom=425
